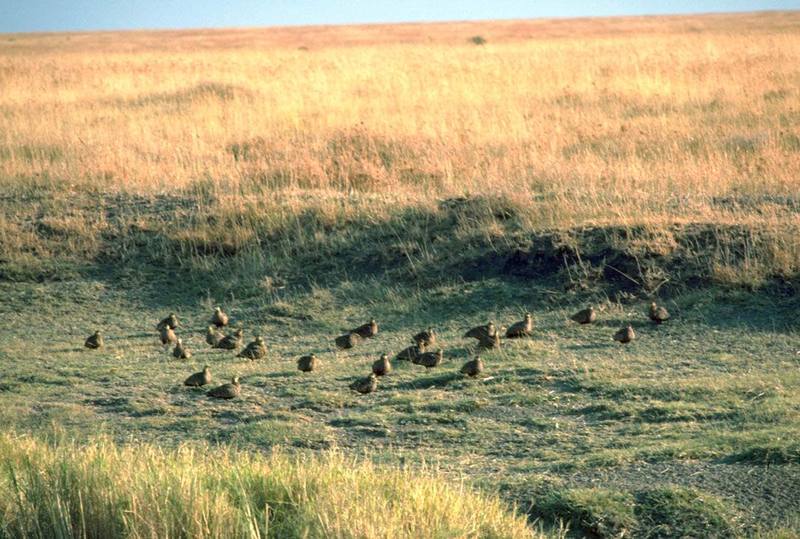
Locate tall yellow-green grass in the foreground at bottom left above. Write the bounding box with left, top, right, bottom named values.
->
left=0, top=435, right=531, bottom=538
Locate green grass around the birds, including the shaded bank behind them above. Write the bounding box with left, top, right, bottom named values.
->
left=0, top=185, right=800, bottom=537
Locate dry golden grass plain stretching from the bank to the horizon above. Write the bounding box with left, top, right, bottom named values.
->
left=0, top=13, right=800, bottom=228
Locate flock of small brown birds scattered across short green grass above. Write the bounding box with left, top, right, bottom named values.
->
left=84, top=302, right=670, bottom=399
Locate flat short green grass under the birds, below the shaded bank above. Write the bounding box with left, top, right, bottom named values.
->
left=0, top=254, right=800, bottom=537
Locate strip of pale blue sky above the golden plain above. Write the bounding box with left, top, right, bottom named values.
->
left=0, top=0, right=800, bottom=33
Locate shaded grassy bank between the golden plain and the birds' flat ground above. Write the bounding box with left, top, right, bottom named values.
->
left=0, top=191, right=800, bottom=297
